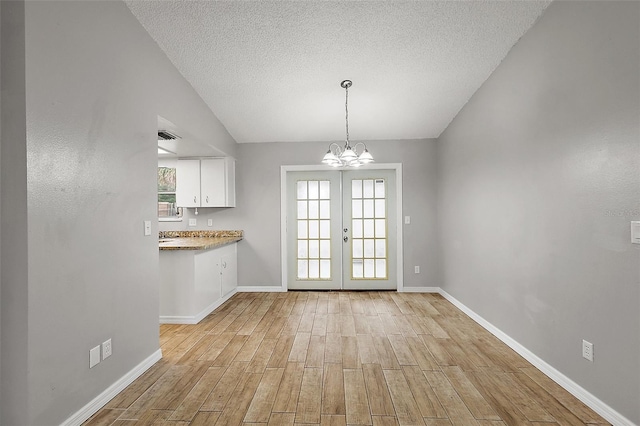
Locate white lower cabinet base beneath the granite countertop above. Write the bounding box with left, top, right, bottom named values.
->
left=159, top=243, right=238, bottom=324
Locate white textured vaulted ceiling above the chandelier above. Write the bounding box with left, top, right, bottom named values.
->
left=126, top=0, right=549, bottom=143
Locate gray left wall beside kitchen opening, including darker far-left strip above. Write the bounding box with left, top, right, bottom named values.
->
left=0, top=1, right=236, bottom=425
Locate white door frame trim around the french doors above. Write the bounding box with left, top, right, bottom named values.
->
left=280, top=163, right=404, bottom=292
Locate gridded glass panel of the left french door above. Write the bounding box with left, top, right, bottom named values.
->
left=296, top=180, right=331, bottom=280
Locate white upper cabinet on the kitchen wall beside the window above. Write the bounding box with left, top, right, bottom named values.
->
left=176, top=157, right=236, bottom=207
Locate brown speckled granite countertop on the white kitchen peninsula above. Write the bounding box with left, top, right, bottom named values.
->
left=158, top=231, right=243, bottom=250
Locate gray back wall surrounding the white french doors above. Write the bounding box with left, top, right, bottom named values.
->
left=161, top=140, right=440, bottom=287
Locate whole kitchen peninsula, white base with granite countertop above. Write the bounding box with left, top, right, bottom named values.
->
left=158, top=231, right=243, bottom=324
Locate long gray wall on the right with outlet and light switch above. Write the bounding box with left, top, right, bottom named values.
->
left=438, top=2, right=640, bottom=424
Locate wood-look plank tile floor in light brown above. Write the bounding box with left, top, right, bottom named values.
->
left=85, top=292, right=609, bottom=426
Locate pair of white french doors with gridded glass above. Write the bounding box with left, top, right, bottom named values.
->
left=285, top=169, right=398, bottom=290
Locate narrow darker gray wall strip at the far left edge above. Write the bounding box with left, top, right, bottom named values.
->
left=0, top=2, right=28, bottom=424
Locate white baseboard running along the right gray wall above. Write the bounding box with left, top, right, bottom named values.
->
left=439, top=289, right=637, bottom=426
